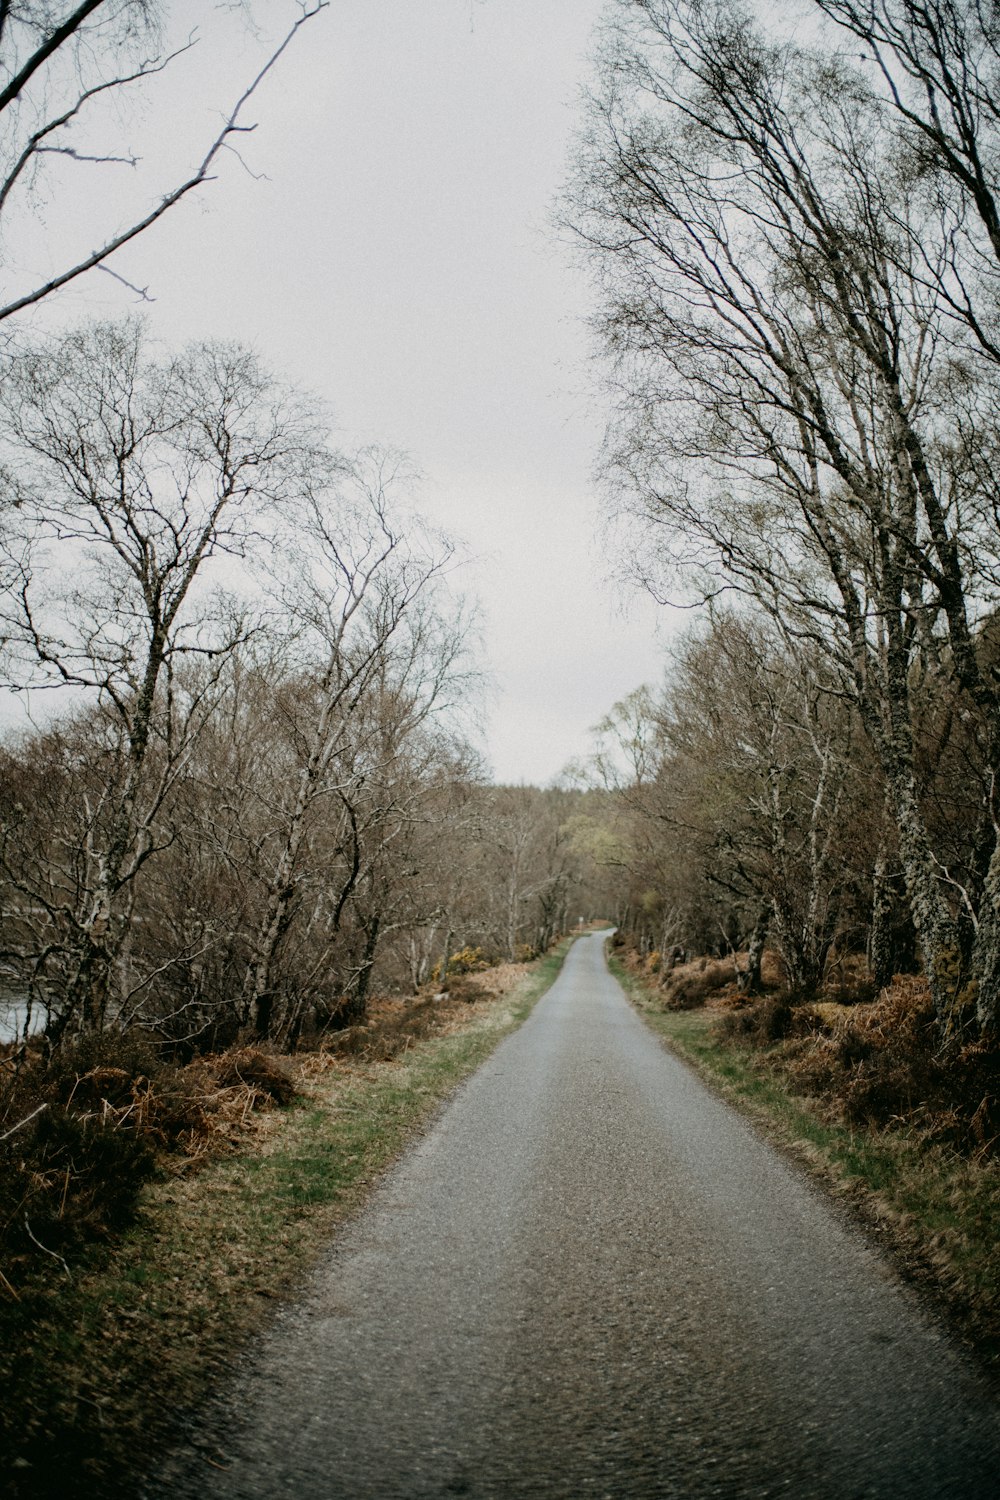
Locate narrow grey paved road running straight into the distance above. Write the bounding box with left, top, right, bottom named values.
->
left=147, top=936, right=1000, bottom=1500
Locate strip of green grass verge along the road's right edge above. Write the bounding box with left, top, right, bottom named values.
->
left=609, top=956, right=1000, bottom=1379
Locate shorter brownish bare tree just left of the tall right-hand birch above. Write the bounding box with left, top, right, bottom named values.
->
left=660, top=614, right=879, bottom=995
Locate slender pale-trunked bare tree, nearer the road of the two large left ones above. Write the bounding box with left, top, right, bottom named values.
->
left=247, top=450, right=476, bottom=1035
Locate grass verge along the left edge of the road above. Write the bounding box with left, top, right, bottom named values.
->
left=0, top=939, right=571, bottom=1500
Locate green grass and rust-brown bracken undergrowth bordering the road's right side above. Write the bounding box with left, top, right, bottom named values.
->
left=610, top=954, right=1000, bottom=1379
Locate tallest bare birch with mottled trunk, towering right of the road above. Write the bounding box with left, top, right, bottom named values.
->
left=574, top=0, right=1000, bottom=1035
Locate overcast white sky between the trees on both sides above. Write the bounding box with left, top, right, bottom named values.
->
left=9, top=0, right=680, bottom=783
